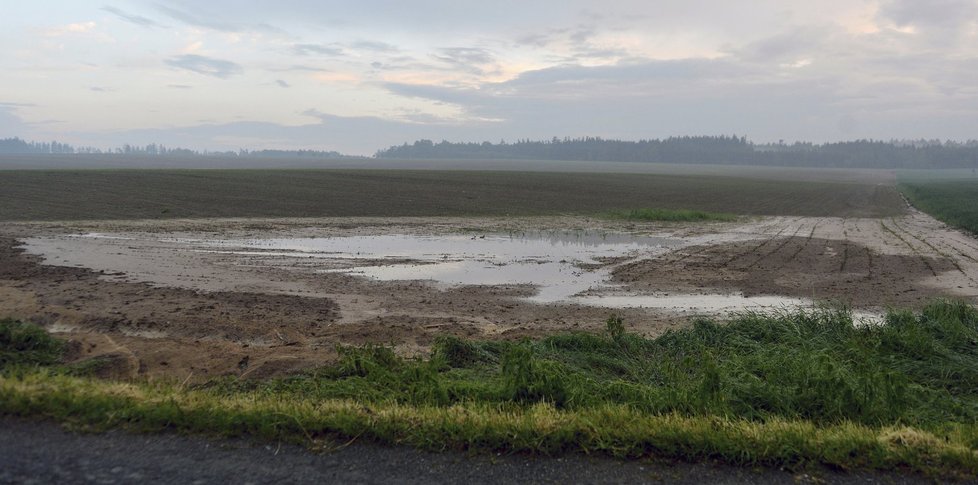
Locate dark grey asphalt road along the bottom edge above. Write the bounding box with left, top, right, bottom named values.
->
left=0, top=418, right=952, bottom=485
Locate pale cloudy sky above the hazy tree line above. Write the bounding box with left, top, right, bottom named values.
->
left=0, top=0, right=978, bottom=155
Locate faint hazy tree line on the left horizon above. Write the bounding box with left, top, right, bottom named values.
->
left=0, top=138, right=346, bottom=158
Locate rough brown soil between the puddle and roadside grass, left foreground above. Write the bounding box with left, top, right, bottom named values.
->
left=0, top=221, right=676, bottom=381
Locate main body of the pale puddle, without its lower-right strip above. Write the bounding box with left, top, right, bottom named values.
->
left=205, top=232, right=683, bottom=303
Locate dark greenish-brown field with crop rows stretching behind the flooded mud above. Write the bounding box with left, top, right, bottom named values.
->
left=0, top=166, right=902, bottom=221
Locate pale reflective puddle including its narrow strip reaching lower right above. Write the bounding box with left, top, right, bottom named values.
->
left=194, top=232, right=811, bottom=314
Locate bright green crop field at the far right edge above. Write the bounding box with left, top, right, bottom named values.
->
left=899, top=178, right=978, bottom=235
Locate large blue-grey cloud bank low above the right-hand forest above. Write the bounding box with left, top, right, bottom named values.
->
left=383, top=56, right=978, bottom=141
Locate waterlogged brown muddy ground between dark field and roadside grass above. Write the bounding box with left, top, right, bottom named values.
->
left=0, top=205, right=978, bottom=380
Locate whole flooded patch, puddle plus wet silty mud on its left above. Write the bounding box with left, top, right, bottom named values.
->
left=26, top=231, right=832, bottom=315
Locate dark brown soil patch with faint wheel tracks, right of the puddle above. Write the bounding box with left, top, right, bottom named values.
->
left=614, top=236, right=955, bottom=308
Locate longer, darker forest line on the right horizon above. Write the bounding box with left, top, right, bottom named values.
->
left=375, top=136, right=978, bottom=169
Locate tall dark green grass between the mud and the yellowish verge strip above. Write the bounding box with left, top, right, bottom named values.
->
left=206, top=302, right=978, bottom=426
